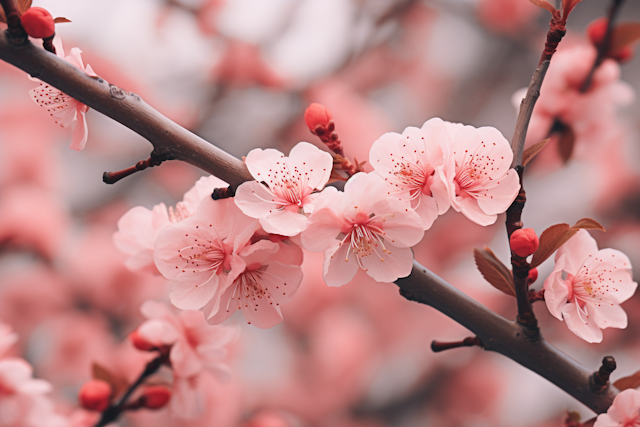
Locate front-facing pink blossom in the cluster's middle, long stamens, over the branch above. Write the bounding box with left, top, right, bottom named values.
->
left=302, top=173, right=424, bottom=286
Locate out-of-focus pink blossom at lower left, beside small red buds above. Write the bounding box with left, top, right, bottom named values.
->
left=138, top=301, right=237, bottom=418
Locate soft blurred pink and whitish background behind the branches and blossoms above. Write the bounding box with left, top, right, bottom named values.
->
left=0, top=0, right=640, bottom=427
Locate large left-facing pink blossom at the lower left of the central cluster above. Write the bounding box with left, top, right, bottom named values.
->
left=153, top=198, right=257, bottom=310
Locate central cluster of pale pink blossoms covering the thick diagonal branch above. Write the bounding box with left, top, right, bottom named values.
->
left=114, top=118, right=520, bottom=328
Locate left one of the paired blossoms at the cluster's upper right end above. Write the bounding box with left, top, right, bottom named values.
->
left=369, top=118, right=455, bottom=230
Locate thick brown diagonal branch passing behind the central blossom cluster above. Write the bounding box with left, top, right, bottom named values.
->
left=0, top=28, right=615, bottom=413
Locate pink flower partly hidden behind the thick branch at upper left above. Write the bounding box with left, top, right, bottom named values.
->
left=29, top=37, right=98, bottom=151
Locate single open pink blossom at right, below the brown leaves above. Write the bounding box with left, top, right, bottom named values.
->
left=544, top=230, right=638, bottom=342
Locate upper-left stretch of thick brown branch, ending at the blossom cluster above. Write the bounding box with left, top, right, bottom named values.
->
left=0, top=30, right=252, bottom=187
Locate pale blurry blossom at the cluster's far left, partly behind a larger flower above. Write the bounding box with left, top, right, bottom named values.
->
left=113, top=176, right=228, bottom=274
